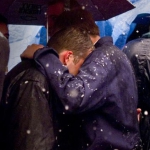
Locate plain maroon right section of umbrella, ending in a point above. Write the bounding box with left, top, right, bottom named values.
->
left=78, top=0, right=135, bottom=21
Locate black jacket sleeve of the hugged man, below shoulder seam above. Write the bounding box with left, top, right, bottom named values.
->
left=2, top=73, right=55, bottom=150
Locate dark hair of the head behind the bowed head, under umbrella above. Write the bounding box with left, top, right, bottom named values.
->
left=54, top=9, right=99, bottom=36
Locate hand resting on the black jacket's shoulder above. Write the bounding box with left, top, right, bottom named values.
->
left=20, top=44, right=44, bottom=59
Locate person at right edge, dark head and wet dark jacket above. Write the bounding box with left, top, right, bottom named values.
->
left=123, top=13, right=150, bottom=150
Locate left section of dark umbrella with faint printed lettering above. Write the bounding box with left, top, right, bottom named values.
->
left=0, top=0, right=48, bottom=25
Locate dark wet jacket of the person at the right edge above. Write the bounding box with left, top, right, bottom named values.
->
left=123, top=38, right=150, bottom=150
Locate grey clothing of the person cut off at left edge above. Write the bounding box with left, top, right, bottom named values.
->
left=0, top=32, right=9, bottom=100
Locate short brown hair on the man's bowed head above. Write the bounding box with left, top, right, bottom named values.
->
left=48, top=26, right=94, bottom=58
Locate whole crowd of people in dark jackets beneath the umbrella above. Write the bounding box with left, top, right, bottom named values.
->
left=0, top=0, right=150, bottom=150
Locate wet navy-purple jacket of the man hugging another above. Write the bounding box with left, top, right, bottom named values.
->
left=34, top=37, right=140, bottom=150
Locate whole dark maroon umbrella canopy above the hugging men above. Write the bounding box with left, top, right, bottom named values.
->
left=0, top=0, right=135, bottom=25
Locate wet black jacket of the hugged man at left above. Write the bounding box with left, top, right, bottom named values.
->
left=0, top=60, right=55, bottom=150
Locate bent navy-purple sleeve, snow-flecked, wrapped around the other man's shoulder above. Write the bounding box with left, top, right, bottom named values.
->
left=34, top=49, right=107, bottom=113
